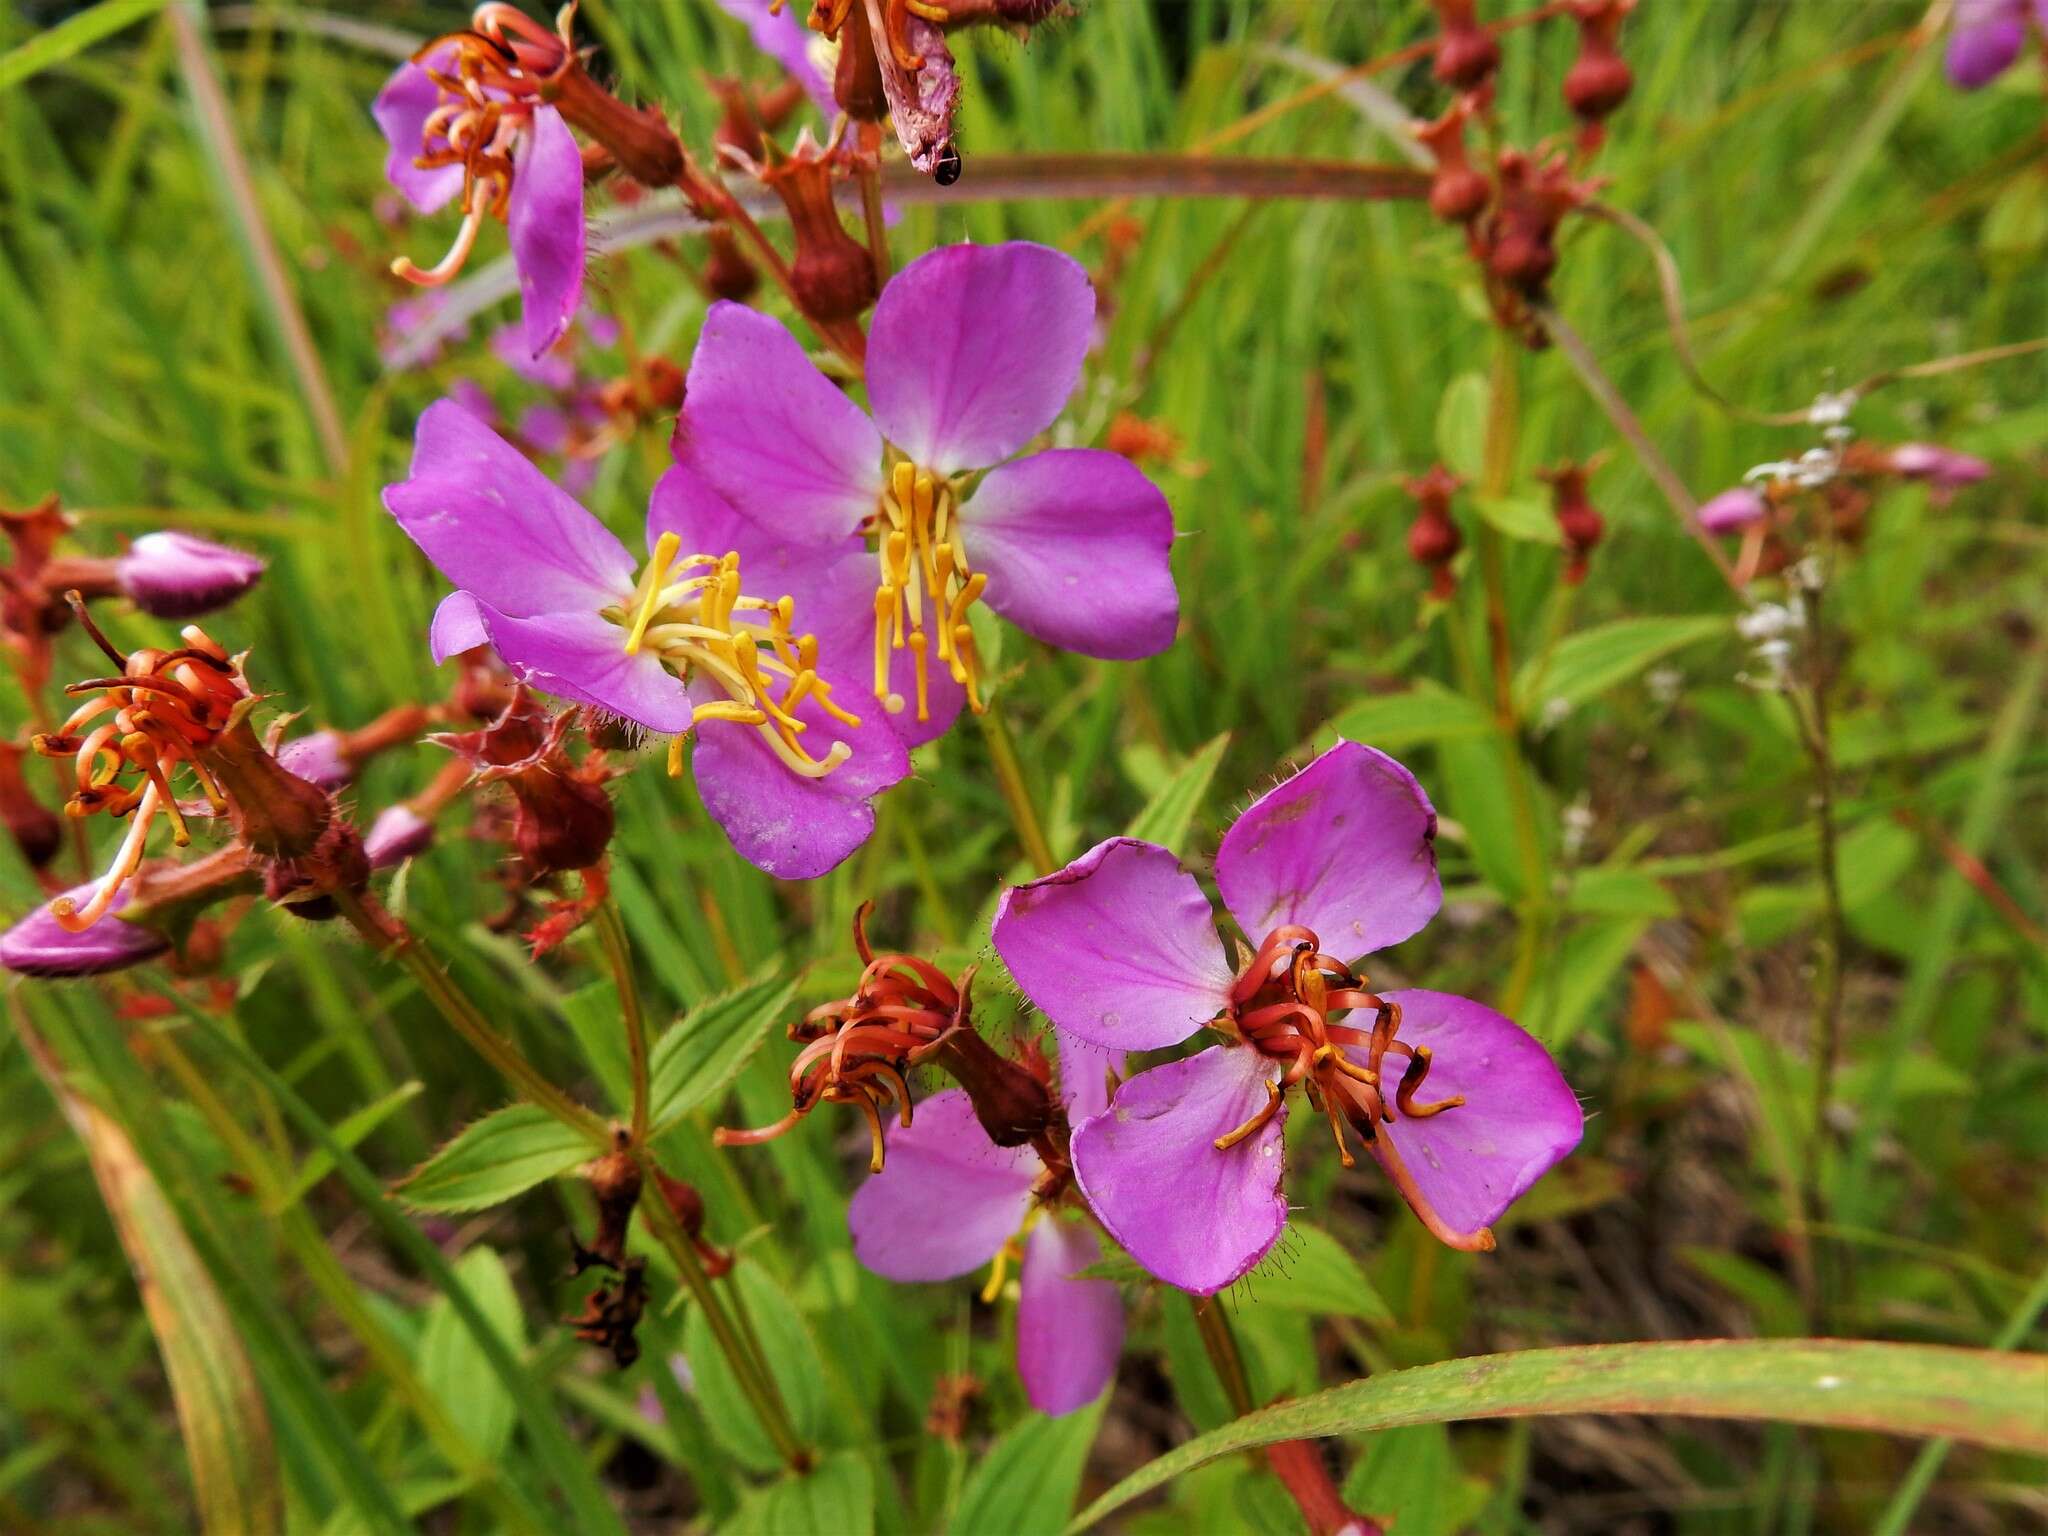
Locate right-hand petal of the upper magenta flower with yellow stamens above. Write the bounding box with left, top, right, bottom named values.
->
left=961, top=449, right=1180, bottom=662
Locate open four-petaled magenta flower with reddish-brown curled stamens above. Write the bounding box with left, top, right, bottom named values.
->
left=993, top=741, right=1583, bottom=1294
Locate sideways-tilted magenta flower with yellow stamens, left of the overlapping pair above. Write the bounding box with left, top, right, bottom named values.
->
left=383, top=399, right=909, bottom=879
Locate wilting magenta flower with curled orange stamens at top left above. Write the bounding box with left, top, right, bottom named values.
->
left=371, top=20, right=584, bottom=356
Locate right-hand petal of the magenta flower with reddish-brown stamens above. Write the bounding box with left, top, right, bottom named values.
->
left=1376, top=987, right=1585, bottom=1233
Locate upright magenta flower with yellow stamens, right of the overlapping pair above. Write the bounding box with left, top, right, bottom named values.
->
left=676, top=244, right=1180, bottom=745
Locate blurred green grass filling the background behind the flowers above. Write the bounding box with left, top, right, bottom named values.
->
left=0, top=0, right=2048, bottom=1536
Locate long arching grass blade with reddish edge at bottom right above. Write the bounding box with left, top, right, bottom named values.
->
left=1067, top=1339, right=2048, bottom=1532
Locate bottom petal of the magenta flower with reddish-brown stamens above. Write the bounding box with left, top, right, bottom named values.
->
left=1073, top=1047, right=1286, bottom=1296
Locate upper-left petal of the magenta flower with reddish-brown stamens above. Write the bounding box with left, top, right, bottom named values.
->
left=991, top=838, right=1231, bottom=1051
